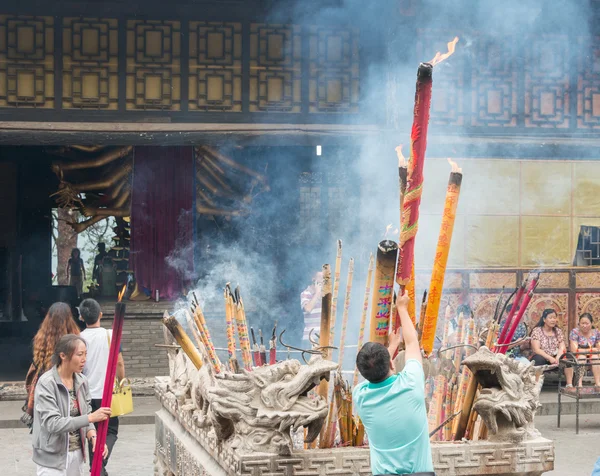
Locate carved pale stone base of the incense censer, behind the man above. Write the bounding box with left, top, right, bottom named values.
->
left=155, top=386, right=554, bottom=476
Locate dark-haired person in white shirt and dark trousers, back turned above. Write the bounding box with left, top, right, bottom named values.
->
left=79, top=299, right=125, bottom=476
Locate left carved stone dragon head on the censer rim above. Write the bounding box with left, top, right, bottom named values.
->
left=158, top=331, right=337, bottom=456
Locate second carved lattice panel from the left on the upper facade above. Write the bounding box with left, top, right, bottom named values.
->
left=63, top=17, right=119, bottom=110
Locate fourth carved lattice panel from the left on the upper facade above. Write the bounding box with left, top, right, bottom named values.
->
left=188, top=21, right=242, bottom=112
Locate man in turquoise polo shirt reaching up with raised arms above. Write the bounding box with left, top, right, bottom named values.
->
left=352, top=293, right=434, bottom=476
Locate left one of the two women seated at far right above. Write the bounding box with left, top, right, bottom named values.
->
left=531, top=309, right=566, bottom=365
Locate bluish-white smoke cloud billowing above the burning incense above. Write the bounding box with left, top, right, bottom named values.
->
left=169, top=0, right=597, bottom=367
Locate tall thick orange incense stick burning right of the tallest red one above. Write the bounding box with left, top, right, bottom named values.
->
left=421, top=162, right=462, bottom=354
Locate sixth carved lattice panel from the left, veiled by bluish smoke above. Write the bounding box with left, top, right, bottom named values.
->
left=308, top=26, right=360, bottom=113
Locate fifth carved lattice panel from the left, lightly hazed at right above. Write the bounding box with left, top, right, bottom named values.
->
left=249, top=23, right=302, bottom=113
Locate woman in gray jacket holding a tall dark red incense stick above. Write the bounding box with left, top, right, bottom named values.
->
left=33, top=334, right=110, bottom=476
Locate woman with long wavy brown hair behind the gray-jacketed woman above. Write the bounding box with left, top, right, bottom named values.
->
left=21, top=302, right=79, bottom=427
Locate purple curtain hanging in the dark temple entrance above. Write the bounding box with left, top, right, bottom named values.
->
left=130, top=147, right=194, bottom=299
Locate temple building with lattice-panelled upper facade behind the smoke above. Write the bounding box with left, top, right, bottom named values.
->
left=0, top=0, right=600, bottom=380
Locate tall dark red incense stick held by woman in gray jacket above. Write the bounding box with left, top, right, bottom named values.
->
left=91, top=298, right=125, bottom=476
